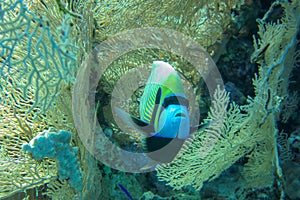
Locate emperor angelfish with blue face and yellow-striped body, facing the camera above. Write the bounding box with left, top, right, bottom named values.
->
left=116, top=61, right=197, bottom=163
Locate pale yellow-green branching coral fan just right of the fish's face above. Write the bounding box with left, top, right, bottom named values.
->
left=157, top=88, right=251, bottom=189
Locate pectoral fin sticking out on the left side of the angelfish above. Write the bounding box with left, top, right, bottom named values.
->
left=114, top=107, right=154, bottom=135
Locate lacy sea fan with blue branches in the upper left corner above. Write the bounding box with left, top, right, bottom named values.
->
left=0, top=0, right=77, bottom=112
